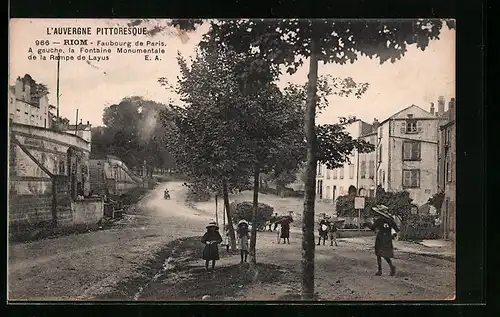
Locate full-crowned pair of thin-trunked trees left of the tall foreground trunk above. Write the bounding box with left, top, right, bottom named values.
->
left=159, top=39, right=374, bottom=263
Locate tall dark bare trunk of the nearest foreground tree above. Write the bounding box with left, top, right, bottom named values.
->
left=302, top=39, right=318, bottom=300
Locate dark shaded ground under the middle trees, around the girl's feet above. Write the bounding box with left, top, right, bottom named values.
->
left=98, top=237, right=283, bottom=301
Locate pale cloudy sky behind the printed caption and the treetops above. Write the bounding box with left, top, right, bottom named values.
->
left=9, top=19, right=455, bottom=126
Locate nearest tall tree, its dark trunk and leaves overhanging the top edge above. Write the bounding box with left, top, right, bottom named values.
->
left=134, top=19, right=455, bottom=300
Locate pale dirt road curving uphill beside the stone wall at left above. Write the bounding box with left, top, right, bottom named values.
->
left=8, top=183, right=213, bottom=300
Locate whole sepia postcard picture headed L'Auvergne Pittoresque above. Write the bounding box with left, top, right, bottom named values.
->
left=7, top=18, right=460, bottom=303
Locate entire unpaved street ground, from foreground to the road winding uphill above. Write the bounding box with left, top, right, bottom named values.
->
left=9, top=183, right=455, bottom=301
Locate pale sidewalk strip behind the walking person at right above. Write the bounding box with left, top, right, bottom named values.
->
left=339, top=237, right=455, bottom=261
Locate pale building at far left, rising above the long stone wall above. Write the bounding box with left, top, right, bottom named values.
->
left=9, top=78, right=50, bottom=128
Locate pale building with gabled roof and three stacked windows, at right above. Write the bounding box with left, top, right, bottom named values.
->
left=375, top=100, right=444, bottom=206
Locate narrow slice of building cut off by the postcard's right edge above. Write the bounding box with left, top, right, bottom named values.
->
left=438, top=98, right=457, bottom=240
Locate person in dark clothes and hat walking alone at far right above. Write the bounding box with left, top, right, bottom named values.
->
left=371, top=205, right=399, bottom=276
